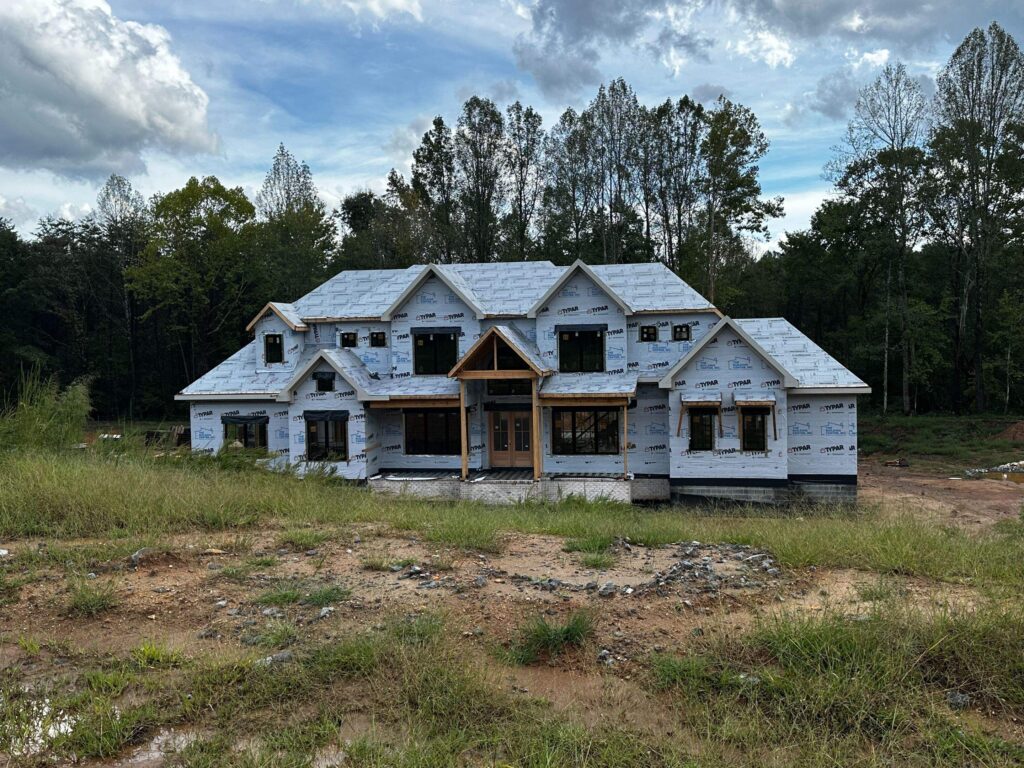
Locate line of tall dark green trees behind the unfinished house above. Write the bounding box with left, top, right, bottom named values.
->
left=0, top=24, right=1024, bottom=418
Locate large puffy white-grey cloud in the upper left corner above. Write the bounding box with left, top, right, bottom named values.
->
left=0, top=0, right=217, bottom=177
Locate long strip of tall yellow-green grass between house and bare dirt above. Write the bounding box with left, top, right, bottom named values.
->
left=6, top=453, right=1024, bottom=587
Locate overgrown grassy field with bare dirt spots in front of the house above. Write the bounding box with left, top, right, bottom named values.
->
left=0, top=420, right=1024, bottom=768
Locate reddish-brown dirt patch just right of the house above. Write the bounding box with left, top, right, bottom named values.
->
left=858, top=463, right=1024, bottom=529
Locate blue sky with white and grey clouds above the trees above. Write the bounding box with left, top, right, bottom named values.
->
left=0, top=0, right=1024, bottom=247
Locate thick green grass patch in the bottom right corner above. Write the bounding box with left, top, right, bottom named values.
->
left=650, top=603, right=1024, bottom=766
